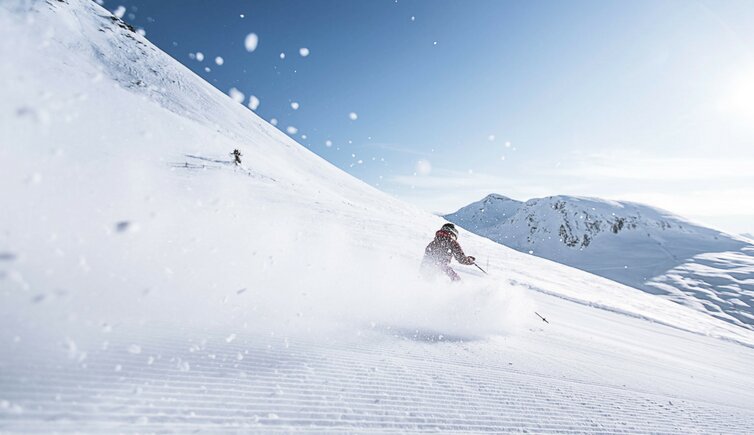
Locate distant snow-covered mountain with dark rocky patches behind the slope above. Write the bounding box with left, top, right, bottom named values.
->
left=445, top=194, right=754, bottom=329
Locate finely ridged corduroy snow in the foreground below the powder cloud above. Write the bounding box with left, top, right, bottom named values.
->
left=0, top=324, right=754, bottom=433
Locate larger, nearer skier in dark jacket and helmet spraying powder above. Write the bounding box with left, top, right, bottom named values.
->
left=421, top=224, right=476, bottom=281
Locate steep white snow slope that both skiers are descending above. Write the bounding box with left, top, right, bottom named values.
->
left=0, top=0, right=754, bottom=433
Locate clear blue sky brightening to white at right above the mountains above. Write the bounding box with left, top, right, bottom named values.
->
left=104, top=0, right=754, bottom=237
